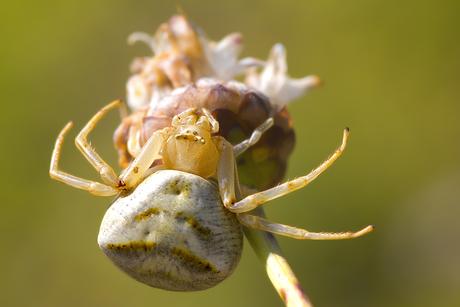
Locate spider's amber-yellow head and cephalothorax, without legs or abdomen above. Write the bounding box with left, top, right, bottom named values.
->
left=161, top=108, right=219, bottom=178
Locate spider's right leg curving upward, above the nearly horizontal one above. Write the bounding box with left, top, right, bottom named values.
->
left=228, top=128, right=349, bottom=213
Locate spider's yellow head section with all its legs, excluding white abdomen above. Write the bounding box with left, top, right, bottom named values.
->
left=50, top=100, right=373, bottom=240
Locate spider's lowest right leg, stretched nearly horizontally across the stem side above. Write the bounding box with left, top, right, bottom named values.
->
left=236, top=213, right=374, bottom=240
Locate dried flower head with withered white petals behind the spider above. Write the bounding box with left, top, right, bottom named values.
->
left=114, top=15, right=319, bottom=189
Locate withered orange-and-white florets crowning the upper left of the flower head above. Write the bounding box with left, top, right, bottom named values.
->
left=127, top=15, right=263, bottom=110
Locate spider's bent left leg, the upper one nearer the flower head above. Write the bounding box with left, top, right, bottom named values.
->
left=75, top=100, right=121, bottom=187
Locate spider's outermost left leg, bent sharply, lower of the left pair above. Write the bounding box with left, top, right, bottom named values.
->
left=50, top=122, right=118, bottom=196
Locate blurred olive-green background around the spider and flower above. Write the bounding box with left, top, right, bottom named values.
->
left=0, top=0, right=460, bottom=307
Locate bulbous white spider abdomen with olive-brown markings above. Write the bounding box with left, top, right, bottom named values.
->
left=98, top=170, right=243, bottom=291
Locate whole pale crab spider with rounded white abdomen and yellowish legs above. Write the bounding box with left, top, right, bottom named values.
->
left=50, top=101, right=373, bottom=291
